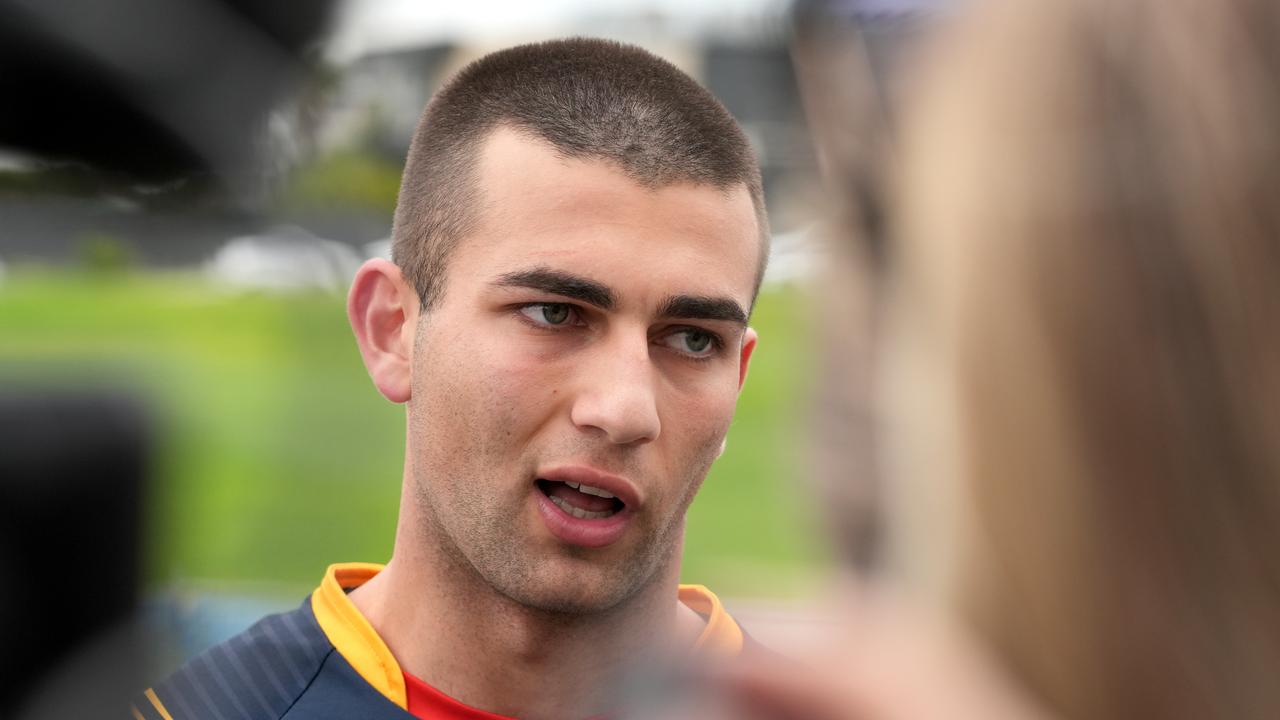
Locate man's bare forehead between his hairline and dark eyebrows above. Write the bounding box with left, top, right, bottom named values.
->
left=463, top=128, right=760, bottom=300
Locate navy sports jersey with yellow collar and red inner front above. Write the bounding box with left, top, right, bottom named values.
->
left=131, top=562, right=750, bottom=720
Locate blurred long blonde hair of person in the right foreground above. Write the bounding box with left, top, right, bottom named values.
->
left=888, top=0, right=1280, bottom=719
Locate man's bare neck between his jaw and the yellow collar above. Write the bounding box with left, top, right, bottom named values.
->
left=351, top=538, right=703, bottom=719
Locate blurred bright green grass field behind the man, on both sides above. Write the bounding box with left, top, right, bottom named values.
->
left=0, top=268, right=824, bottom=597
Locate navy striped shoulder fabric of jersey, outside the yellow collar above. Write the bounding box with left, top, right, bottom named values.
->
left=133, top=598, right=413, bottom=720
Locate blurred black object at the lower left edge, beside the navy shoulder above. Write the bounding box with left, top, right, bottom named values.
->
left=0, top=392, right=147, bottom=719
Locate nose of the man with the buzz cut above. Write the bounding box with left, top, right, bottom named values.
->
left=571, top=337, right=662, bottom=445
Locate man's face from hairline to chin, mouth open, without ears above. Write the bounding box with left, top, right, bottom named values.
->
left=408, top=129, right=759, bottom=612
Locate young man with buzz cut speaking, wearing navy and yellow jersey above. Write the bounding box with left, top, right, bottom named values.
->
left=134, top=40, right=768, bottom=720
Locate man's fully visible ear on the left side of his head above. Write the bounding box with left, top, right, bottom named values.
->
left=347, top=258, right=420, bottom=402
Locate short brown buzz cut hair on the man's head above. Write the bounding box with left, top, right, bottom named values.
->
left=392, top=38, right=769, bottom=310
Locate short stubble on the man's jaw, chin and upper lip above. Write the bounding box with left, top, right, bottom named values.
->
left=408, top=356, right=723, bottom=616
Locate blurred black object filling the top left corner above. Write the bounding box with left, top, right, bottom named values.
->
left=0, top=0, right=334, bottom=184
